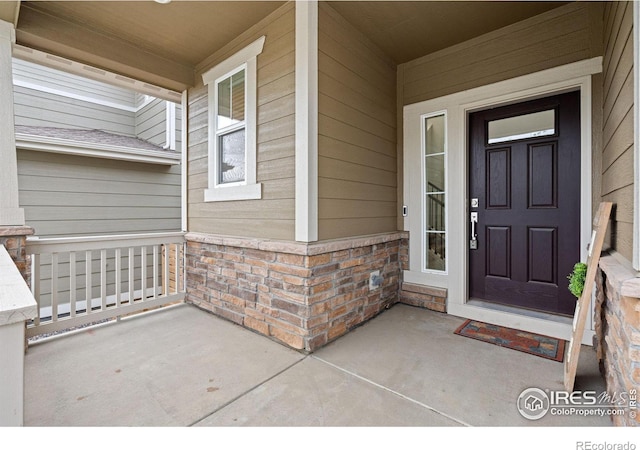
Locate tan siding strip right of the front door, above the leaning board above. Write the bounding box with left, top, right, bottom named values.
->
left=602, top=2, right=637, bottom=260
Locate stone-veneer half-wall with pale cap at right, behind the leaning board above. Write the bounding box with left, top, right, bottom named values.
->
left=595, top=256, right=640, bottom=426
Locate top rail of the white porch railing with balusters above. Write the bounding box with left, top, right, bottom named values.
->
left=26, top=231, right=185, bottom=254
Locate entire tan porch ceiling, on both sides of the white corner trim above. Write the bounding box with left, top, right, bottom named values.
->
left=10, top=0, right=567, bottom=91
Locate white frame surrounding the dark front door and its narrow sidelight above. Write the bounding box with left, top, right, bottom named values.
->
left=403, top=57, right=602, bottom=344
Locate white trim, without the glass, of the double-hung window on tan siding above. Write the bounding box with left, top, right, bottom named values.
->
left=202, top=36, right=265, bottom=202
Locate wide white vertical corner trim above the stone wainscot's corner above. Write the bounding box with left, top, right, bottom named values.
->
left=295, top=0, right=318, bottom=242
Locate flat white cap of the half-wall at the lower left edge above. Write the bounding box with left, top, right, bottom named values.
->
left=0, top=245, right=38, bottom=326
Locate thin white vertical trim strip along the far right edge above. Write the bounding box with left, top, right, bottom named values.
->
left=632, top=1, right=640, bottom=270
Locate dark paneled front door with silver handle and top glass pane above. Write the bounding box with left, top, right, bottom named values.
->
left=469, top=92, right=580, bottom=315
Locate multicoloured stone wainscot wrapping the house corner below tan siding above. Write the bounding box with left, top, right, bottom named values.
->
left=186, top=232, right=408, bottom=352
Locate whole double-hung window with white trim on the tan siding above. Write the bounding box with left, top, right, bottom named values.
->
left=202, top=36, right=265, bottom=202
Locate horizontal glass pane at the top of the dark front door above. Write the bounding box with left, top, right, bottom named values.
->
left=489, top=109, right=556, bottom=144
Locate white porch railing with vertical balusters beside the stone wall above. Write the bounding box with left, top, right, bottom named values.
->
left=27, top=233, right=185, bottom=337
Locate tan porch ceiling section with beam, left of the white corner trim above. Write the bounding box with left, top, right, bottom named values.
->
left=12, top=1, right=285, bottom=91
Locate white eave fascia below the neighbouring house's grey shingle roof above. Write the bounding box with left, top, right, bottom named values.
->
left=16, top=133, right=181, bottom=165
